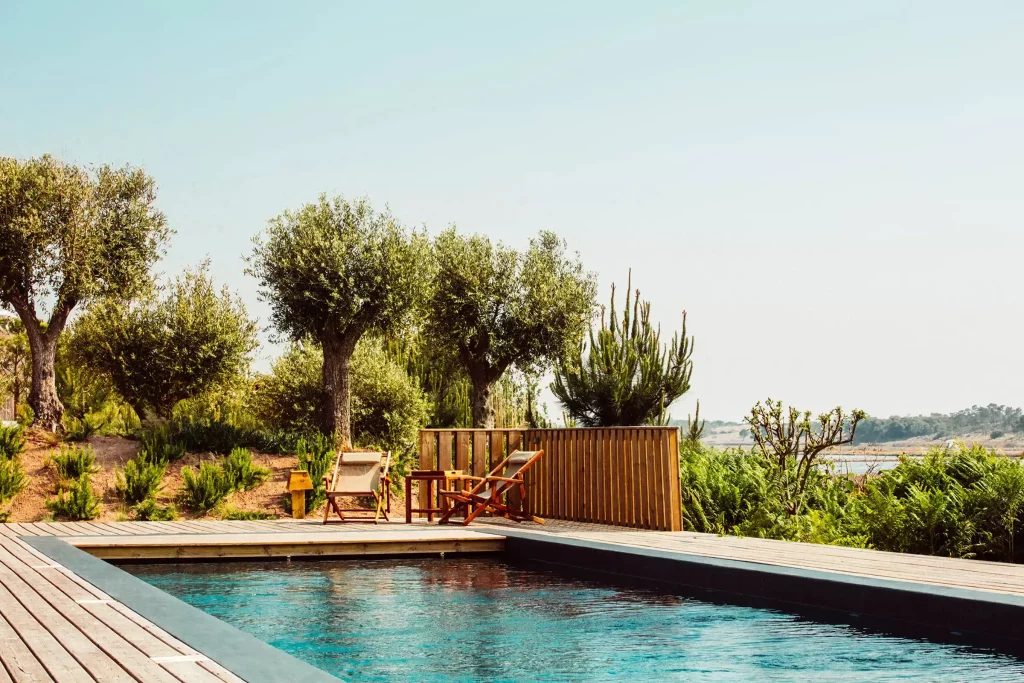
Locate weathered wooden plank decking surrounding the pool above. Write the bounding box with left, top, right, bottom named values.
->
left=6, top=520, right=1024, bottom=683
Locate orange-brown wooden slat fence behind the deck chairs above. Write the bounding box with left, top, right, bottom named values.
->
left=418, top=427, right=683, bottom=531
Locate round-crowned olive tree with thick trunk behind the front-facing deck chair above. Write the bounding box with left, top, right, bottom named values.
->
left=248, top=195, right=430, bottom=443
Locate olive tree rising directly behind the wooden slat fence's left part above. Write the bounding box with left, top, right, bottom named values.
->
left=428, top=232, right=596, bottom=428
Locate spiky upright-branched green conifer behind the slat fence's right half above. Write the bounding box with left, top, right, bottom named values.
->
left=551, top=271, right=693, bottom=427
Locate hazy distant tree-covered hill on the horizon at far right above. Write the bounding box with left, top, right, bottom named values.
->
left=854, top=403, right=1024, bottom=443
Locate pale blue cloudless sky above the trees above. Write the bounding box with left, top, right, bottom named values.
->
left=0, top=0, right=1024, bottom=419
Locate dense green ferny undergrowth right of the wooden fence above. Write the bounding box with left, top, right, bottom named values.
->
left=680, top=441, right=1024, bottom=562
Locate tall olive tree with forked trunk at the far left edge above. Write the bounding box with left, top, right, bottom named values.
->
left=0, top=156, right=170, bottom=431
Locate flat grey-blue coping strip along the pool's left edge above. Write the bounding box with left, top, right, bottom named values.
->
left=20, top=536, right=340, bottom=683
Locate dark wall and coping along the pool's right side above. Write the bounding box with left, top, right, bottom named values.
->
left=479, top=526, right=1024, bottom=654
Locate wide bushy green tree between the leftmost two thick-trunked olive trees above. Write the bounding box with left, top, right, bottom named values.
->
left=70, top=262, right=258, bottom=417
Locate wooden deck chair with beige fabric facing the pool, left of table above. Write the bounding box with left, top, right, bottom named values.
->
left=324, top=452, right=391, bottom=524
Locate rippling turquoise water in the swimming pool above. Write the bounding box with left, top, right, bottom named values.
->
left=124, top=558, right=1024, bottom=682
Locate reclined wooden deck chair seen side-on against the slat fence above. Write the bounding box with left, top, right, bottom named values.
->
left=437, top=451, right=544, bottom=525
